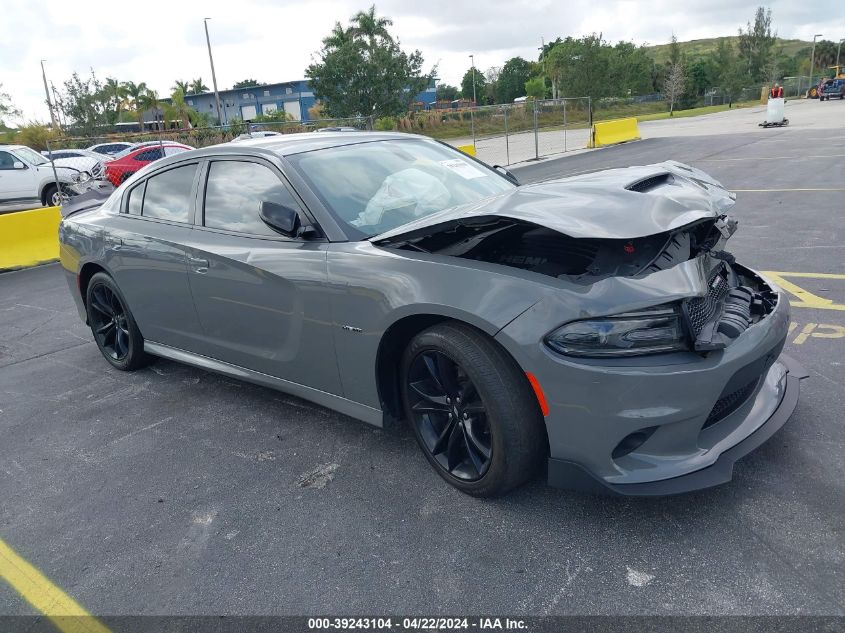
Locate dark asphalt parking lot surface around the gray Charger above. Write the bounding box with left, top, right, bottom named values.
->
left=0, top=102, right=845, bottom=615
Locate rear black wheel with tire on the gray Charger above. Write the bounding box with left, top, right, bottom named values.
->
left=85, top=273, right=151, bottom=371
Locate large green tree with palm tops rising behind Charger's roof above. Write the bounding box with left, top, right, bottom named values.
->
left=305, top=6, right=436, bottom=117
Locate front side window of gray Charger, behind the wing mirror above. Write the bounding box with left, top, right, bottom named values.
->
left=204, top=161, right=299, bottom=237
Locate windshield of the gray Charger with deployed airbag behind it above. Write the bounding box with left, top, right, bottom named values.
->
left=287, top=139, right=514, bottom=238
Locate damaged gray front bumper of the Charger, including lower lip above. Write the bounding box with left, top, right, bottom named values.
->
left=498, top=258, right=805, bottom=495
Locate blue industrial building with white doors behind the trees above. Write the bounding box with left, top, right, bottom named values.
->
left=185, top=79, right=437, bottom=122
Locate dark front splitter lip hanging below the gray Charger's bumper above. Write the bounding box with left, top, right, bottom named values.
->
left=548, top=355, right=807, bottom=496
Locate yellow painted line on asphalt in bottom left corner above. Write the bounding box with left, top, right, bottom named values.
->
left=0, top=539, right=110, bottom=633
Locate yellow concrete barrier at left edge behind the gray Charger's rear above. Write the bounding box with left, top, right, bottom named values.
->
left=0, top=207, right=62, bottom=270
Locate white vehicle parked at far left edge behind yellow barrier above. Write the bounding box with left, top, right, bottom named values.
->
left=0, top=145, right=91, bottom=206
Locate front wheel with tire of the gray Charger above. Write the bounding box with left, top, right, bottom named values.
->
left=400, top=323, right=548, bottom=497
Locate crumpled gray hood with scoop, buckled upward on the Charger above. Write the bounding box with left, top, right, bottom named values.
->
left=372, top=161, right=735, bottom=243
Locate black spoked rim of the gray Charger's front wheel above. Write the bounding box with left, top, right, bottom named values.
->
left=408, top=351, right=492, bottom=481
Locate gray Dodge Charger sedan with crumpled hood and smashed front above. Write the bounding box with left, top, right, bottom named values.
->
left=60, top=133, right=804, bottom=496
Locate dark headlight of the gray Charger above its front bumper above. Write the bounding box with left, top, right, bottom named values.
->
left=545, top=305, right=689, bottom=358
